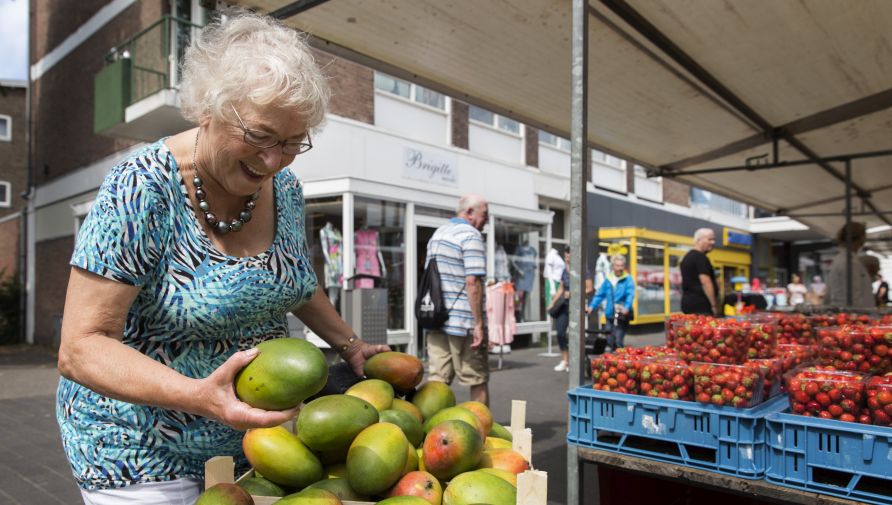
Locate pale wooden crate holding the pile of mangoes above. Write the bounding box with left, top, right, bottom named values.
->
left=204, top=400, right=548, bottom=505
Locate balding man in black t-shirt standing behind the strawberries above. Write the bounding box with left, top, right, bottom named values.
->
left=679, top=228, right=719, bottom=315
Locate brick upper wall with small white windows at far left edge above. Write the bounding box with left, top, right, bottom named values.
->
left=0, top=87, right=28, bottom=217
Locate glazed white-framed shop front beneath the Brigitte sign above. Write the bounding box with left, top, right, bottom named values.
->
left=292, top=178, right=552, bottom=353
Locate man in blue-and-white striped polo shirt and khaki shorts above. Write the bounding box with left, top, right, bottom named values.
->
left=425, top=195, right=489, bottom=405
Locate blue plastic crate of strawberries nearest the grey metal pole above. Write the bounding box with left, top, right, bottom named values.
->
left=567, top=386, right=787, bottom=479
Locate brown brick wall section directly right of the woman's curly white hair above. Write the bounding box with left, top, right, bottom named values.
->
left=313, top=49, right=375, bottom=124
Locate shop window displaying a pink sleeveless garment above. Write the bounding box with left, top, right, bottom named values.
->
left=353, top=198, right=406, bottom=330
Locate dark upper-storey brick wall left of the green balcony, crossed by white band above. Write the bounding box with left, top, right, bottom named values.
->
left=31, top=0, right=168, bottom=185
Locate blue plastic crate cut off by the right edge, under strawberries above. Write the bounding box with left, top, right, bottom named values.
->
left=765, top=412, right=892, bottom=504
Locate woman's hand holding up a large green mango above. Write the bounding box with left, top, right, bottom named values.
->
left=195, top=348, right=300, bottom=431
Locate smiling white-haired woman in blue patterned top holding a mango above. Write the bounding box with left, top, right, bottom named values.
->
left=57, top=13, right=387, bottom=504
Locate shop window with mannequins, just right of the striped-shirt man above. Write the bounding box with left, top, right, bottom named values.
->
left=487, top=218, right=548, bottom=323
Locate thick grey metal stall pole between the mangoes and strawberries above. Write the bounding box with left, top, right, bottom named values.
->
left=567, top=0, right=597, bottom=505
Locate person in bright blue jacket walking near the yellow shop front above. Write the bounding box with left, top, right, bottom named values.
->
left=586, top=254, right=635, bottom=350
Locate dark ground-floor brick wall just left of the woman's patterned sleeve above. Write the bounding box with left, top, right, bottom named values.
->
left=34, top=236, right=74, bottom=345
